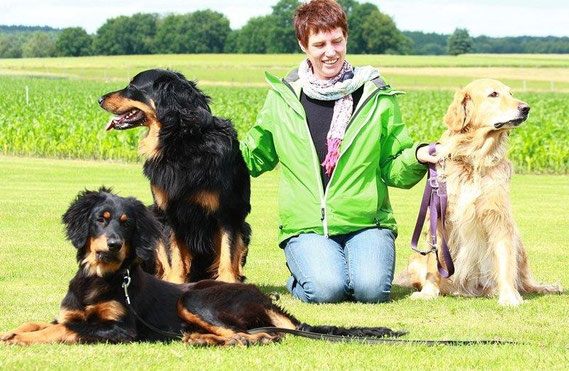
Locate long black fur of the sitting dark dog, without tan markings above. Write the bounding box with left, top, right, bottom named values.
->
left=101, top=70, right=251, bottom=281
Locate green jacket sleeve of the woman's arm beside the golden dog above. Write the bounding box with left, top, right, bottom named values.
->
left=380, top=96, right=427, bottom=188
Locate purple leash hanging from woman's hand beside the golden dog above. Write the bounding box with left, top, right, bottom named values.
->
left=411, top=143, right=454, bottom=278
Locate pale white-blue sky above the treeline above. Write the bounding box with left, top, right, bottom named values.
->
left=0, top=0, right=569, bottom=37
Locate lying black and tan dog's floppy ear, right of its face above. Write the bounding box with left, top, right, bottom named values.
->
left=128, top=197, right=162, bottom=261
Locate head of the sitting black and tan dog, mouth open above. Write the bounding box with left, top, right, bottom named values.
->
left=99, top=69, right=213, bottom=155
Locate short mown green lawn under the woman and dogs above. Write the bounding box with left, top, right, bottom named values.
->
left=0, top=156, right=569, bottom=369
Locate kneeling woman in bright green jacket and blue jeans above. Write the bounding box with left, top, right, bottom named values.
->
left=241, top=0, right=435, bottom=303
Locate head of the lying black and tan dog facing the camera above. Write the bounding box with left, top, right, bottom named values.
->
left=62, top=188, right=161, bottom=277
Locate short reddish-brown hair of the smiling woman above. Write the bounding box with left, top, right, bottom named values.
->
left=294, top=0, right=348, bottom=48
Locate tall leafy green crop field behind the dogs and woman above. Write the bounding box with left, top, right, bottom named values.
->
left=0, top=72, right=569, bottom=174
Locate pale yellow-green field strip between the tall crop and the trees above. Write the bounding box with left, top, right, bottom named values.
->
left=0, top=54, right=569, bottom=92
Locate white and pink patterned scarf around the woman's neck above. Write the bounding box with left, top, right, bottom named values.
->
left=298, top=59, right=379, bottom=176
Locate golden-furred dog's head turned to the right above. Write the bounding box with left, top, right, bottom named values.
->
left=444, top=79, right=530, bottom=133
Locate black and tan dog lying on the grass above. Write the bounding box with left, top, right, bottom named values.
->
left=0, top=188, right=403, bottom=345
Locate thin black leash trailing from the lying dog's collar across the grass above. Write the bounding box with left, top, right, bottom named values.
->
left=122, top=269, right=520, bottom=346
